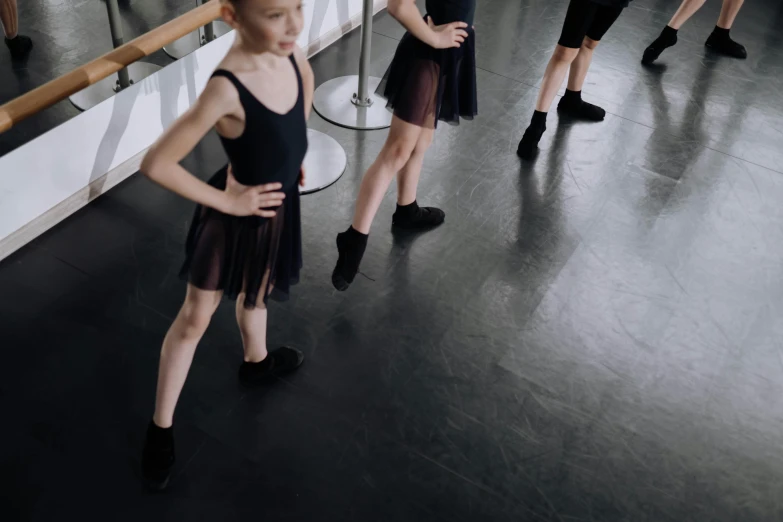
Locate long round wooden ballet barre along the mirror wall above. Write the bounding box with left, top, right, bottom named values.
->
left=0, top=0, right=220, bottom=132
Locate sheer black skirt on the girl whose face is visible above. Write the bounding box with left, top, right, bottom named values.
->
left=180, top=166, right=302, bottom=309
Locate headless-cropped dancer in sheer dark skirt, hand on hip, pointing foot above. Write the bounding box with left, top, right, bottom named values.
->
left=332, top=0, right=478, bottom=290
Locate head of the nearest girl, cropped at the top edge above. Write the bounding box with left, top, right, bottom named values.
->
left=223, top=0, right=304, bottom=56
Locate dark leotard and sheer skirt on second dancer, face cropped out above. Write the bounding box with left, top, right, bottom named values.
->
left=376, top=0, right=478, bottom=129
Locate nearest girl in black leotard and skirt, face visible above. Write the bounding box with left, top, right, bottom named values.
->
left=141, top=0, right=313, bottom=489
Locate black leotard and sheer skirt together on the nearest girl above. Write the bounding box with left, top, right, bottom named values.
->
left=180, top=56, right=307, bottom=309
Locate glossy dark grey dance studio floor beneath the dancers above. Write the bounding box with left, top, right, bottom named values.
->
left=0, top=0, right=783, bottom=522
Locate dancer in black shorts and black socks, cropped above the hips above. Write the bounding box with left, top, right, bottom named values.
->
left=517, top=0, right=630, bottom=159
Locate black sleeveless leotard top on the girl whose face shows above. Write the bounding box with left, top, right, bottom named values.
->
left=212, top=55, right=307, bottom=192
